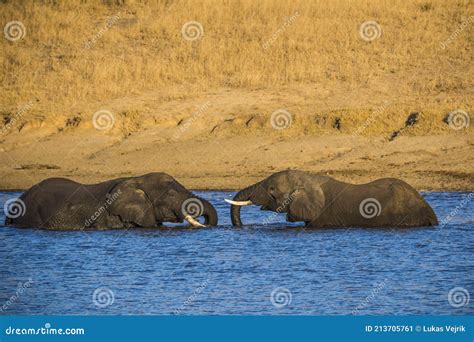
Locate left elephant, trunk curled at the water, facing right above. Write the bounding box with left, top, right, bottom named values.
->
left=5, top=173, right=217, bottom=229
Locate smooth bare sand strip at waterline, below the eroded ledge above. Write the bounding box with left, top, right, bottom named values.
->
left=0, top=123, right=474, bottom=191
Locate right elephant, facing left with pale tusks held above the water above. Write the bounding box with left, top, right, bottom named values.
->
left=226, top=170, right=438, bottom=227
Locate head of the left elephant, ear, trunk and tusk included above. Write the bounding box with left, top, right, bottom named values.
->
left=107, top=173, right=217, bottom=227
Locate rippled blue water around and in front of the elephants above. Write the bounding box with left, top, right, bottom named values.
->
left=0, top=192, right=474, bottom=315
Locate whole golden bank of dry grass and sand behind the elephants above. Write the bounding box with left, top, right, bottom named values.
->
left=0, top=0, right=474, bottom=189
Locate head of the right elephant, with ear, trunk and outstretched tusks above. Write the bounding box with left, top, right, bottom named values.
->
left=226, top=170, right=329, bottom=226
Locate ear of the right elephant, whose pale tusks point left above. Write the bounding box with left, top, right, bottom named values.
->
left=287, top=185, right=325, bottom=222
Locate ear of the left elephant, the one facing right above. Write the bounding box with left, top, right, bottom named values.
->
left=107, top=179, right=156, bottom=227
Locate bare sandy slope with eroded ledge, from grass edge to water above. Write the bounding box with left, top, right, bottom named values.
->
left=0, top=90, right=474, bottom=190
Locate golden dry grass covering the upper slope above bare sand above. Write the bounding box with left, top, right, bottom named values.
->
left=0, top=0, right=474, bottom=134
